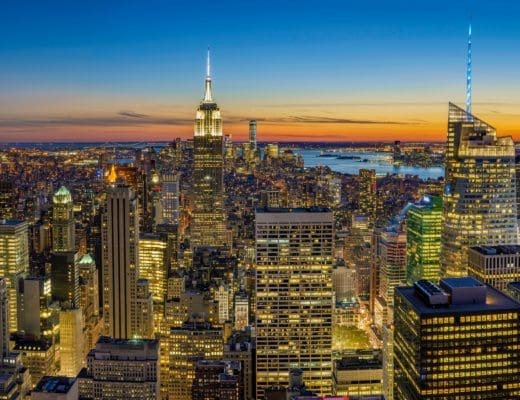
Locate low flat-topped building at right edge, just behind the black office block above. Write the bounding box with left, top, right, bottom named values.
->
left=468, top=245, right=520, bottom=292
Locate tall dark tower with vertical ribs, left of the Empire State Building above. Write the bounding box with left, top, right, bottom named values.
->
left=102, top=182, right=139, bottom=339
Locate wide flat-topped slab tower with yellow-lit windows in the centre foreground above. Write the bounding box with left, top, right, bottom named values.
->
left=256, top=208, right=334, bottom=399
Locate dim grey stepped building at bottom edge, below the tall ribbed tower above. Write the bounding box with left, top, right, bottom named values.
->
left=78, top=336, right=160, bottom=400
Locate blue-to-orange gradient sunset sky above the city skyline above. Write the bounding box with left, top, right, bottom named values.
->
left=0, top=0, right=520, bottom=142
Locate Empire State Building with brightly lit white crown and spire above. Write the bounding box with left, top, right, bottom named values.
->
left=191, top=51, right=226, bottom=247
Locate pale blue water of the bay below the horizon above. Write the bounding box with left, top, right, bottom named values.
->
left=293, top=149, right=444, bottom=179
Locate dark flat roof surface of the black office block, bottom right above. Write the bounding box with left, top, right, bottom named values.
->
left=395, top=285, right=520, bottom=315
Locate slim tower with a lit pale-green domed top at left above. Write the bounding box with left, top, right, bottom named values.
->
left=52, top=186, right=75, bottom=252
